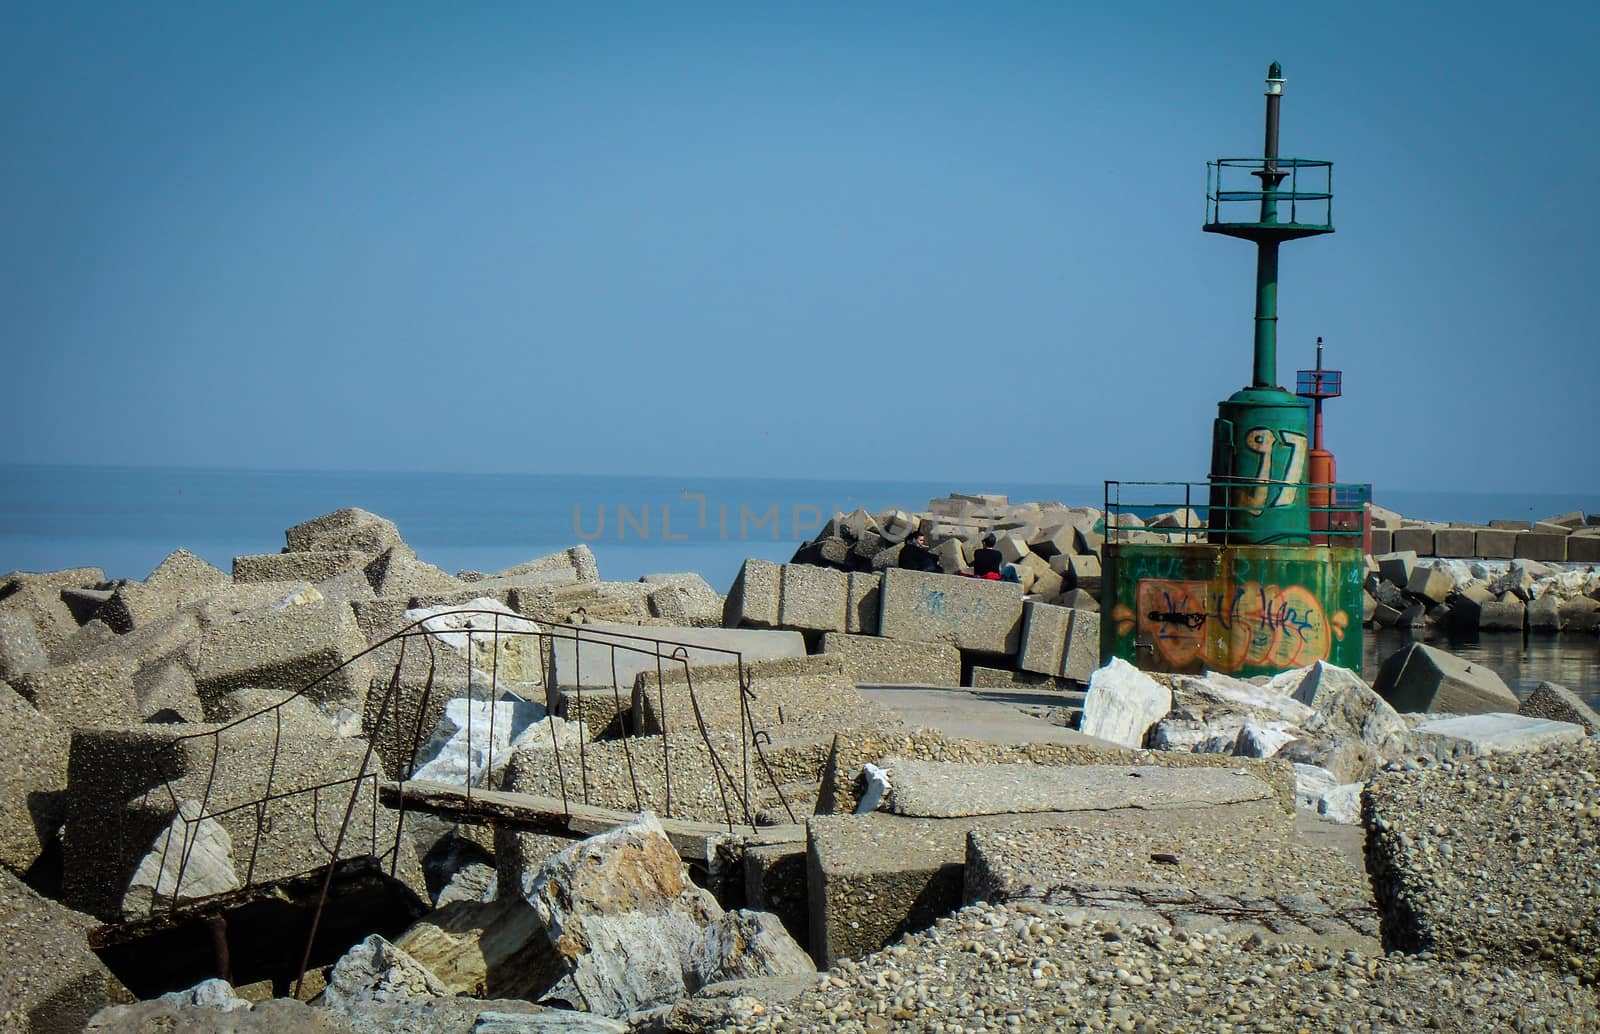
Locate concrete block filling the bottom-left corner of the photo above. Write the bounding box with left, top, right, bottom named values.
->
left=0, top=872, right=125, bottom=1034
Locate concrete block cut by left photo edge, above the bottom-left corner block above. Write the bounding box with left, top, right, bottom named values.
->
left=0, top=683, right=67, bottom=872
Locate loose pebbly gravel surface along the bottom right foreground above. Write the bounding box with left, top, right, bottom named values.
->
left=715, top=903, right=1600, bottom=1034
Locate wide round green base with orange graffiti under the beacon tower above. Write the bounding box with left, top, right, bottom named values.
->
left=1101, top=543, right=1366, bottom=677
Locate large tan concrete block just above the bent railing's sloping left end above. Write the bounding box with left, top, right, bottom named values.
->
left=195, top=603, right=371, bottom=712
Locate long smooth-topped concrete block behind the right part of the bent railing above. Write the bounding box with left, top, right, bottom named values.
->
left=550, top=621, right=805, bottom=691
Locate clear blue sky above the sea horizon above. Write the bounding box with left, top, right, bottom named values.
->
left=0, top=0, right=1600, bottom=491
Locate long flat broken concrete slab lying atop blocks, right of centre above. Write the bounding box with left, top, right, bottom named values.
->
left=883, top=757, right=1282, bottom=818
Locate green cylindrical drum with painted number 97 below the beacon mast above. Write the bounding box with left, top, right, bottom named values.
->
left=1208, top=387, right=1310, bottom=544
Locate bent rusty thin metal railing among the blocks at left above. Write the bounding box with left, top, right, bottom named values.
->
left=117, top=607, right=795, bottom=953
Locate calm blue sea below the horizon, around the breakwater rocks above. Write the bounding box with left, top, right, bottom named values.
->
left=0, top=464, right=1600, bottom=704
